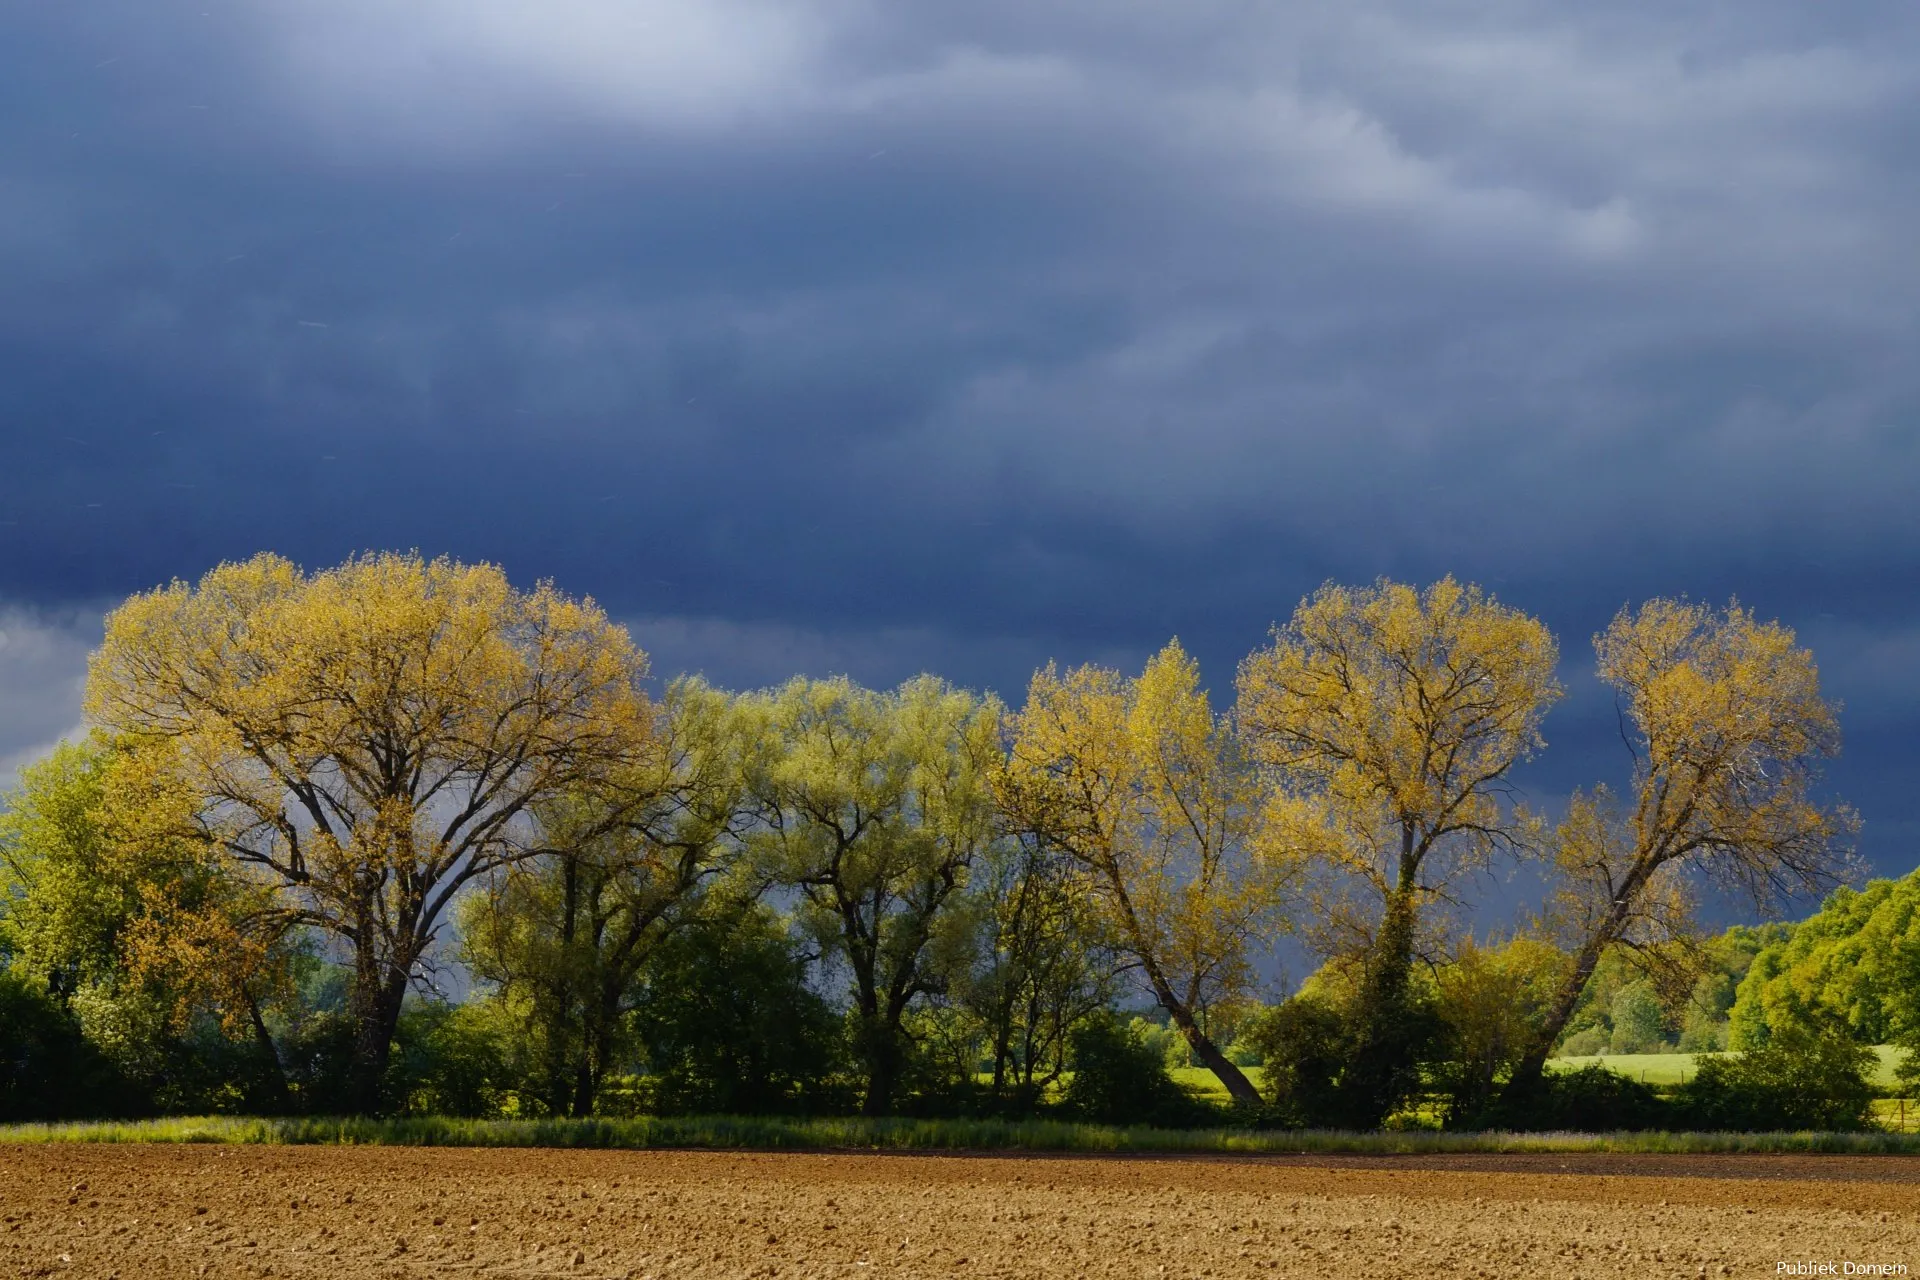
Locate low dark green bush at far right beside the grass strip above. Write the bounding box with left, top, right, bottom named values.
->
left=1674, top=1027, right=1874, bottom=1132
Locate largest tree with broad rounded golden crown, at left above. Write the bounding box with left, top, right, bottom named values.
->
left=86, top=555, right=651, bottom=1111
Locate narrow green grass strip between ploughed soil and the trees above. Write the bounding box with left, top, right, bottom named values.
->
left=0, top=1115, right=1920, bottom=1155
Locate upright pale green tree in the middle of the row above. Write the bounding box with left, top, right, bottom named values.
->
left=749, top=676, right=1000, bottom=1115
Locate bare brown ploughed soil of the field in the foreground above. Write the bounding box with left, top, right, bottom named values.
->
left=0, top=1146, right=1920, bottom=1280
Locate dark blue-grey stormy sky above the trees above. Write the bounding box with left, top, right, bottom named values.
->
left=0, top=0, right=1920, bottom=901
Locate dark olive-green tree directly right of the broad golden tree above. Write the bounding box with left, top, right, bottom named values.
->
left=461, top=679, right=751, bottom=1115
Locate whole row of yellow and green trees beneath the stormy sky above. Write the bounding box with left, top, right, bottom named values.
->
left=0, top=555, right=1855, bottom=1126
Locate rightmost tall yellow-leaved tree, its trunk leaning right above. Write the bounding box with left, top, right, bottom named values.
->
left=1513, top=599, right=1857, bottom=1090
